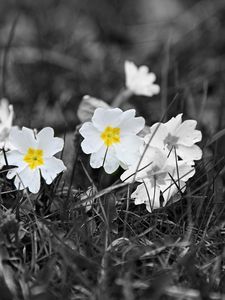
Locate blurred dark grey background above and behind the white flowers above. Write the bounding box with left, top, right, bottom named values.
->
left=0, top=0, right=225, bottom=176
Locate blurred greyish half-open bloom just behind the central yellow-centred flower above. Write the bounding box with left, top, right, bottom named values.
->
left=77, top=95, right=110, bottom=123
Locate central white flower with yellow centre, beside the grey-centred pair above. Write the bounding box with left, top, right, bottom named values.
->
left=80, top=108, right=145, bottom=174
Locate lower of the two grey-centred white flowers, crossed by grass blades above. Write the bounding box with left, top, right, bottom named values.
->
left=121, top=147, right=195, bottom=212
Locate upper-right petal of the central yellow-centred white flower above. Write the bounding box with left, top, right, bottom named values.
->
left=119, top=109, right=145, bottom=135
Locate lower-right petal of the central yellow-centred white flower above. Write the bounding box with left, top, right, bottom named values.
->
left=113, top=135, right=143, bottom=167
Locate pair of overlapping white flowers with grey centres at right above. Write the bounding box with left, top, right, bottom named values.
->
left=121, top=114, right=202, bottom=212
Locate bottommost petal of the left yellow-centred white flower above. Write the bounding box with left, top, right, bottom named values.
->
left=14, top=167, right=40, bottom=194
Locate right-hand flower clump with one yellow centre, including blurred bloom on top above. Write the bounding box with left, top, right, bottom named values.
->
left=78, top=61, right=202, bottom=212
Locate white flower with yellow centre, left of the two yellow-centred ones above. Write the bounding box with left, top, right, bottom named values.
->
left=6, top=127, right=66, bottom=193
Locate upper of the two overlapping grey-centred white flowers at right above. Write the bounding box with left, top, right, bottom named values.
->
left=145, top=114, right=202, bottom=161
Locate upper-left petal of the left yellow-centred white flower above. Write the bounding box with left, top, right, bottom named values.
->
left=9, top=127, right=37, bottom=153
